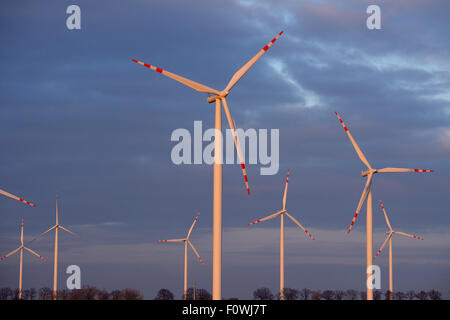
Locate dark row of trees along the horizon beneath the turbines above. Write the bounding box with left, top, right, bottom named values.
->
left=0, top=286, right=442, bottom=300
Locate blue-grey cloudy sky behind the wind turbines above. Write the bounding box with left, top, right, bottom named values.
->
left=0, top=0, right=450, bottom=299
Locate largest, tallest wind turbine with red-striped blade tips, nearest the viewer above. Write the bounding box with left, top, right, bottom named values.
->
left=132, top=31, right=283, bottom=300
